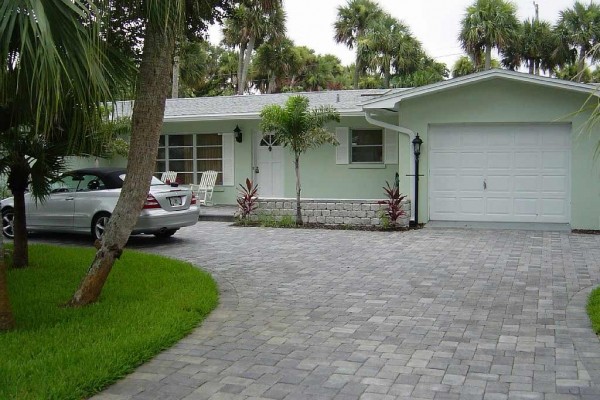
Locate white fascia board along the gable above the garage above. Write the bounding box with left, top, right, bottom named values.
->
left=363, top=70, right=600, bottom=110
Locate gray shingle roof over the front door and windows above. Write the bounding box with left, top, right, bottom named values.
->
left=115, top=89, right=406, bottom=120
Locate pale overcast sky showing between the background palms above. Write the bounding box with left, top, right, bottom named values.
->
left=209, top=0, right=575, bottom=68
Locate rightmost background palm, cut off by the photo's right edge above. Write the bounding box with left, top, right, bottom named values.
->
left=556, top=1, right=600, bottom=80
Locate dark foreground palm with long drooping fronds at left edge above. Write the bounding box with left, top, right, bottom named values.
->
left=0, top=0, right=127, bottom=267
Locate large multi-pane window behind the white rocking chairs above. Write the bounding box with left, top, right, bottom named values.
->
left=156, top=133, right=223, bottom=185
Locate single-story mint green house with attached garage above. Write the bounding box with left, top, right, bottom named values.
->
left=90, top=70, right=600, bottom=229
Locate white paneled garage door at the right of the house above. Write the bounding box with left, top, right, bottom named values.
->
left=429, top=124, right=571, bottom=223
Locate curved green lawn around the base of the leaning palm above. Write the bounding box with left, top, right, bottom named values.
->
left=0, top=245, right=218, bottom=400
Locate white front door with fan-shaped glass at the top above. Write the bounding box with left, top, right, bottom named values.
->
left=254, top=132, right=284, bottom=198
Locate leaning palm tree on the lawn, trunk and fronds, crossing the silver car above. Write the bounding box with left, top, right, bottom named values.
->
left=64, top=0, right=239, bottom=307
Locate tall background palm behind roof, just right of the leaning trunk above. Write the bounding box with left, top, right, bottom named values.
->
left=223, top=0, right=286, bottom=95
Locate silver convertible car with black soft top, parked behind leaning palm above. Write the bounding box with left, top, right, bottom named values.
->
left=0, top=168, right=200, bottom=239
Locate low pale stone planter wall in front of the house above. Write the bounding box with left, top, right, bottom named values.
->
left=254, top=199, right=410, bottom=227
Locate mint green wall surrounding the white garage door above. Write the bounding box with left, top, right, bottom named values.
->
left=398, top=79, right=600, bottom=229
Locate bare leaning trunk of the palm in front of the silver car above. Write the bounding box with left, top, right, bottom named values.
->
left=69, top=19, right=175, bottom=307
